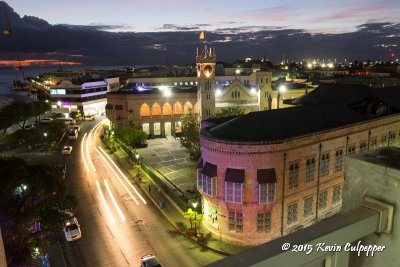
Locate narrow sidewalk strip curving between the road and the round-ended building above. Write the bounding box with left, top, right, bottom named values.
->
left=108, top=142, right=247, bottom=256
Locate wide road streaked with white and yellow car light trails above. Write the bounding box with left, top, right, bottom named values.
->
left=60, top=120, right=222, bottom=266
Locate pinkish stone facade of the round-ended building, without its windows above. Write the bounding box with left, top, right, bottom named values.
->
left=199, top=114, right=400, bottom=245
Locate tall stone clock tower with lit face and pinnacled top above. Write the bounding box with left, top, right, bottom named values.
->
left=196, top=45, right=216, bottom=121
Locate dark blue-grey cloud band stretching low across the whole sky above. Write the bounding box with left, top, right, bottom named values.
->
left=0, top=2, right=400, bottom=65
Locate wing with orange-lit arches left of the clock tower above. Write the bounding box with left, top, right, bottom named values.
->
left=106, top=86, right=199, bottom=137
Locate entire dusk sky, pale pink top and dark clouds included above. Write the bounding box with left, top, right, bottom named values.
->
left=0, top=0, right=400, bottom=65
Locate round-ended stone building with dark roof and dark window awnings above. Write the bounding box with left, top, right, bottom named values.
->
left=197, top=84, right=400, bottom=245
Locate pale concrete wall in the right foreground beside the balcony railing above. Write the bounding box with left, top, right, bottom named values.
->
left=343, top=147, right=400, bottom=267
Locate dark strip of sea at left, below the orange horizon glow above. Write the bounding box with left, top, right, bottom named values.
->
left=0, top=65, right=126, bottom=108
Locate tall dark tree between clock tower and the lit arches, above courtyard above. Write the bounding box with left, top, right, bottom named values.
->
left=181, top=109, right=201, bottom=160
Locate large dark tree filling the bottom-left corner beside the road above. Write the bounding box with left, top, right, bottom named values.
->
left=0, top=158, right=77, bottom=266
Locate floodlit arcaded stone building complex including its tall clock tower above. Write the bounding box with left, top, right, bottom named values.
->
left=106, top=45, right=278, bottom=137
